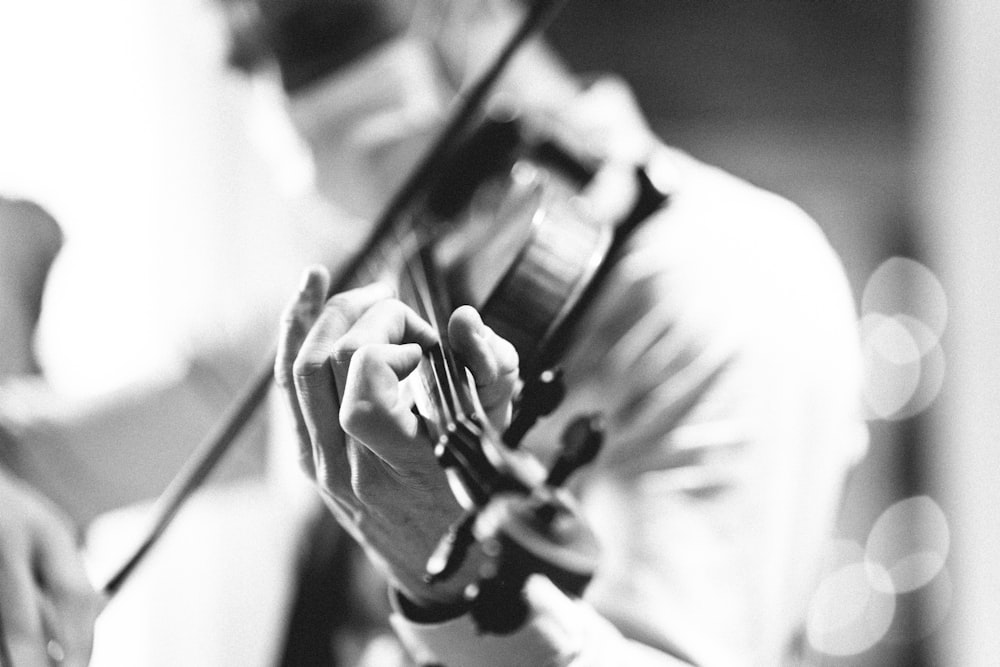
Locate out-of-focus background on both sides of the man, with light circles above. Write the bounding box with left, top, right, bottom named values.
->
left=0, top=0, right=1000, bottom=667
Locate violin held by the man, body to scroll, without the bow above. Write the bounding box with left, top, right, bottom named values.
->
left=386, top=118, right=664, bottom=633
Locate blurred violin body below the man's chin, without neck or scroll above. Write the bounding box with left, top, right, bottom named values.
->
left=412, top=119, right=614, bottom=377
